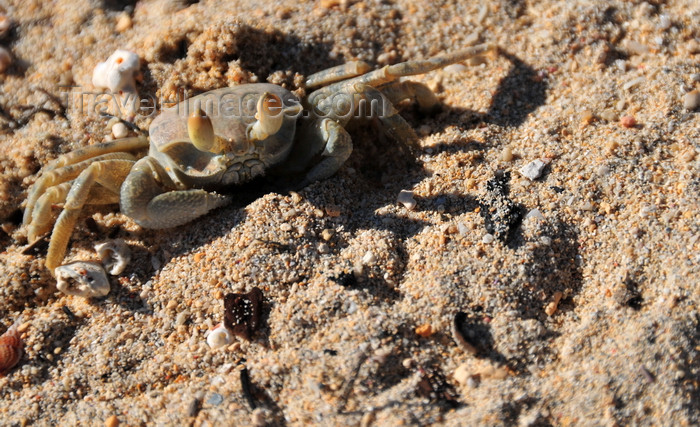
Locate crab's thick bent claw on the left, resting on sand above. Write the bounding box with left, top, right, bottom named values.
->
left=120, top=157, right=229, bottom=228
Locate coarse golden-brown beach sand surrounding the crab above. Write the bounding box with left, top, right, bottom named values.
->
left=0, top=0, right=700, bottom=426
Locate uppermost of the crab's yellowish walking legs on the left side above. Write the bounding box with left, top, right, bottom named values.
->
left=23, top=137, right=148, bottom=226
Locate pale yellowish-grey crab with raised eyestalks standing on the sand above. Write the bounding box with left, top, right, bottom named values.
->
left=23, top=44, right=493, bottom=274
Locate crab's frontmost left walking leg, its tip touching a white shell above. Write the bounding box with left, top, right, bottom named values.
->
left=45, top=159, right=134, bottom=274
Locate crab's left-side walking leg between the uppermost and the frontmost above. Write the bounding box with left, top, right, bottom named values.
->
left=24, top=152, right=135, bottom=242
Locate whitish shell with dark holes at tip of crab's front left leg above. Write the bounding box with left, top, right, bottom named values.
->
left=54, top=261, right=110, bottom=298
